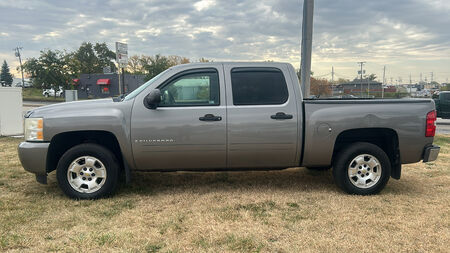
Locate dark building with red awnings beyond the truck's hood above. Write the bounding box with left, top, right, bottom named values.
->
left=73, top=73, right=145, bottom=99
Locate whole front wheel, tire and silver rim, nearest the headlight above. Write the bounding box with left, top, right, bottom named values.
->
left=56, top=143, right=119, bottom=199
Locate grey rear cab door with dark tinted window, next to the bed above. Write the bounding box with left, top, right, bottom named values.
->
left=224, top=64, right=298, bottom=168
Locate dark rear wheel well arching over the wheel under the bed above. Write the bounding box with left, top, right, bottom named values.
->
left=333, top=128, right=401, bottom=179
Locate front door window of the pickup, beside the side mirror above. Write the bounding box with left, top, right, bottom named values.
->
left=159, top=71, right=220, bottom=107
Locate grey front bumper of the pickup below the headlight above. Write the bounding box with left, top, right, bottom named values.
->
left=18, top=142, right=50, bottom=181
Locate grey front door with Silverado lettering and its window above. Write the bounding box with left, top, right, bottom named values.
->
left=131, top=64, right=227, bottom=170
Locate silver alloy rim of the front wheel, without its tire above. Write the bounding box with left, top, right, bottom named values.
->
left=67, top=156, right=106, bottom=193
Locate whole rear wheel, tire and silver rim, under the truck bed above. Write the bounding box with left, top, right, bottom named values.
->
left=333, top=142, right=391, bottom=195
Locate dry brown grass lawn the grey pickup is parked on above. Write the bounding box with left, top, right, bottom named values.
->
left=0, top=136, right=450, bottom=252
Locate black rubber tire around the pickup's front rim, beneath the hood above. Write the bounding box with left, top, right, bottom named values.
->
left=56, top=143, right=120, bottom=199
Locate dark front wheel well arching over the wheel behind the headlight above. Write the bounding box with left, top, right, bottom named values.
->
left=46, top=131, right=123, bottom=172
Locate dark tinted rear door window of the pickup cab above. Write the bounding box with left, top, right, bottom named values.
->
left=231, top=68, right=289, bottom=105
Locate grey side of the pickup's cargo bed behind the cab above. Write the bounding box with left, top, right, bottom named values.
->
left=302, top=99, right=434, bottom=166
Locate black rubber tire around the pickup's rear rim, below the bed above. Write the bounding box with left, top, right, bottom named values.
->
left=333, top=142, right=391, bottom=195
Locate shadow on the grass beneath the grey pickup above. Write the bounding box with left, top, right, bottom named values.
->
left=37, top=168, right=414, bottom=199
